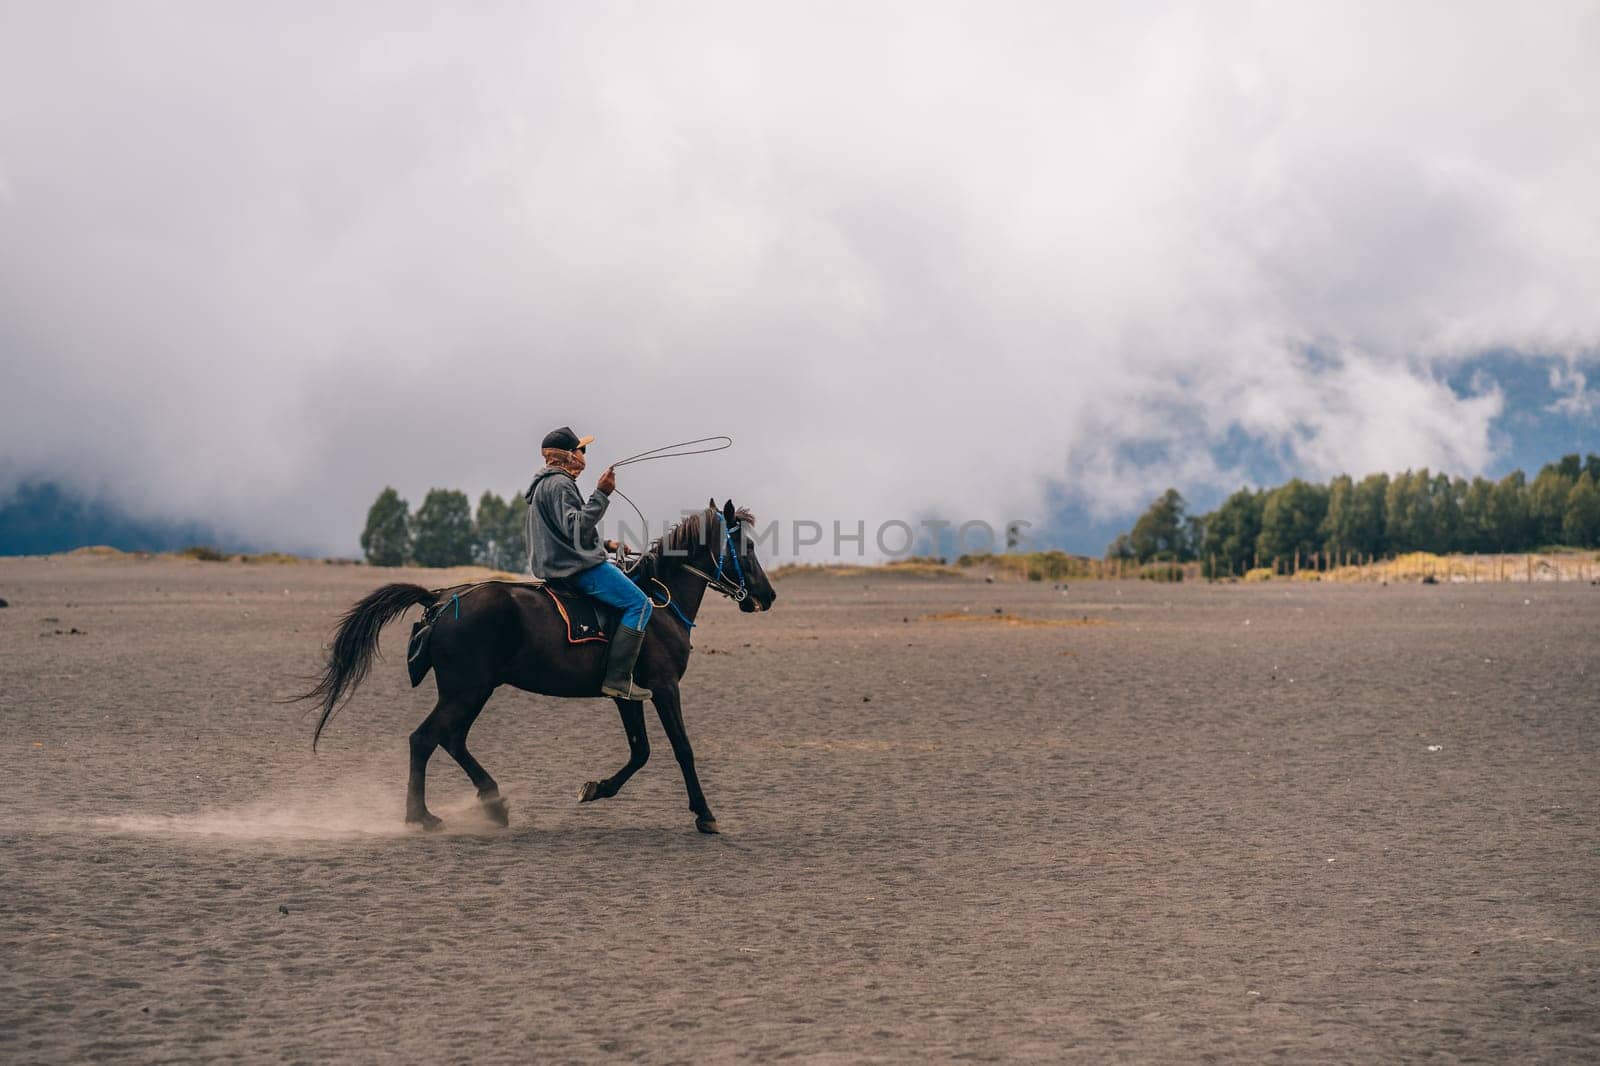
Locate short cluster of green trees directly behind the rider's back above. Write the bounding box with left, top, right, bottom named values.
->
left=362, top=487, right=528, bottom=571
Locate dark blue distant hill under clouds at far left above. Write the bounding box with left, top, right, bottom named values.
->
left=0, top=482, right=242, bottom=555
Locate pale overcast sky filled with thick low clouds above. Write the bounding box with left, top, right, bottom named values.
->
left=0, top=0, right=1600, bottom=552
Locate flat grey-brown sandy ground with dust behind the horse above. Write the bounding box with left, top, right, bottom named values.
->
left=0, top=559, right=1600, bottom=1063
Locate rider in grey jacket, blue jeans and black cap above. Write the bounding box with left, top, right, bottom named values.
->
left=525, top=426, right=650, bottom=701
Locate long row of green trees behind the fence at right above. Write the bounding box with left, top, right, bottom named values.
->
left=1106, top=455, right=1600, bottom=576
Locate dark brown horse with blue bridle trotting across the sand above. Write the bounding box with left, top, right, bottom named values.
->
left=299, top=499, right=778, bottom=832
